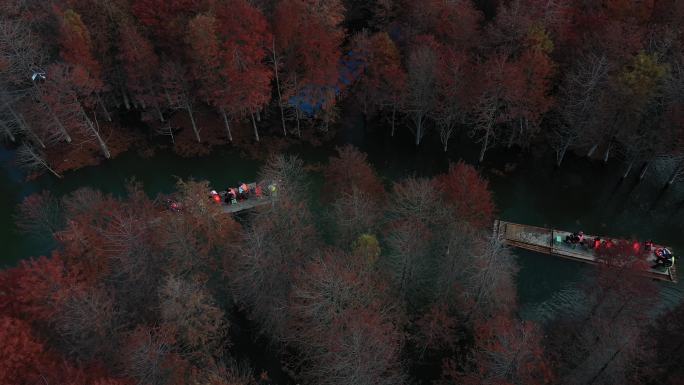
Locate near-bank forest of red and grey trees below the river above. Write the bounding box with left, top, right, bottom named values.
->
left=0, top=146, right=684, bottom=385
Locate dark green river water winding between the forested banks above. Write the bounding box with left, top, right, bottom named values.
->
left=0, top=121, right=684, bottom=318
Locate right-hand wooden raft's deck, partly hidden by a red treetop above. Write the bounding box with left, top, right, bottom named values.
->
left=493, top=220, right=677, bottom=282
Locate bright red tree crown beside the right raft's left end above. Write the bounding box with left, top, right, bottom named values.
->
left=435, top=161, right=495, bottom=228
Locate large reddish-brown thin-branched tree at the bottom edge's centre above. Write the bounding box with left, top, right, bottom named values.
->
left=290, top=254, right=403, bottom=384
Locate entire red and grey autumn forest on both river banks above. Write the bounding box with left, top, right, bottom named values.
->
left=0, top=0, right=684, bottom=385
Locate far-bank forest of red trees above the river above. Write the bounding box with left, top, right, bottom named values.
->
left=0, top=0, right=684, bottom=184
